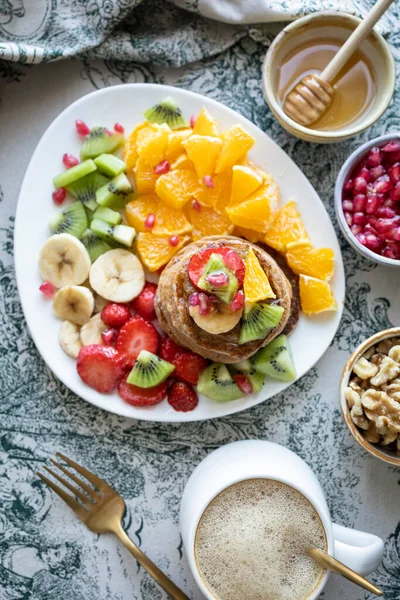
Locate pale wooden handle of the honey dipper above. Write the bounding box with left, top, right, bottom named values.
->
left=320, top=0, right=394, bottom=83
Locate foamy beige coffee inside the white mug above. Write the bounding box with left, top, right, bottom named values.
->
left=195, top=479, right=327, bottom=600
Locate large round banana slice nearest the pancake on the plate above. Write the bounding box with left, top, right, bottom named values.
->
left=89, top=249, right=144, bottom=302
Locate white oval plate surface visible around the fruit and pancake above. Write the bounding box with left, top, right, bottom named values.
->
left=15, top=84, right=345, bottom=422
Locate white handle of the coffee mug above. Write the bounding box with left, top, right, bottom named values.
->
left=332, top=523, right=384, bottom=575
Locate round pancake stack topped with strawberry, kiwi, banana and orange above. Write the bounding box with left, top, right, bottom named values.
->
left=155, top=236, right=293, bottom=363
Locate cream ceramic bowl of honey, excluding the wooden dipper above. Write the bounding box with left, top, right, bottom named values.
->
left=262, top=11, right=396, bottom=143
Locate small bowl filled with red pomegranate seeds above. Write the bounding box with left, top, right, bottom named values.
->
left=335, top=133, right=400, bottom=267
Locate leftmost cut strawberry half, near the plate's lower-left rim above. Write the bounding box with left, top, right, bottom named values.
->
left=76, top=344, right=125, bottom=394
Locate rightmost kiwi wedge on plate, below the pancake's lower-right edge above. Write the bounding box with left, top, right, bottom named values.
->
left=252, top=334, right=296, bottom=381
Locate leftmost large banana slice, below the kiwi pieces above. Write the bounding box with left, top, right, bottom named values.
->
left=39, top=233, right=90, bottom=288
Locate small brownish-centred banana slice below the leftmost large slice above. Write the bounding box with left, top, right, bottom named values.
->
left=53, top=285, right=94, bottom=325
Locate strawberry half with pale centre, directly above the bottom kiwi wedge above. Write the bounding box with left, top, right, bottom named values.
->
left=115, top=316, right=159, bottom=367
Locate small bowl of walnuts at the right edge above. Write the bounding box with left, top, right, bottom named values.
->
left=339, top=327, right=400, bottom=466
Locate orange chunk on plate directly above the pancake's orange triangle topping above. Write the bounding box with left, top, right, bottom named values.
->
left=226, top=185, right=278, bottom=233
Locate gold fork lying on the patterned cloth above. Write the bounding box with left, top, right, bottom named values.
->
left=36, top=452, right=189, bottom=600
